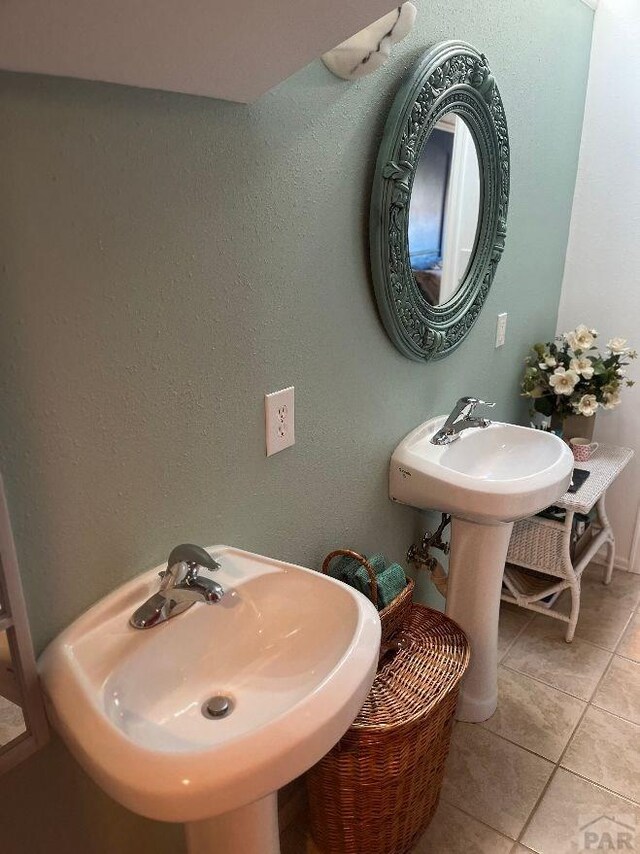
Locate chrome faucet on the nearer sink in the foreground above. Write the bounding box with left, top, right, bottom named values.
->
left=129, top=543, right=224, bottom=629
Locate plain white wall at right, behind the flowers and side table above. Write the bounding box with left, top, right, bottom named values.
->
left=558, top=0, right=640, bottom=572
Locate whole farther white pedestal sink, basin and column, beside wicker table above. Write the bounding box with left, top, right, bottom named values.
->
left=389, top=416, right=573, bottom=721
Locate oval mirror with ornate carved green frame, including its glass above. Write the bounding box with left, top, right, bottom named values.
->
left=371, top=41, right=509, bottom=361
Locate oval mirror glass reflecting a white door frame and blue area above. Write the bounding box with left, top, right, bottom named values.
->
left=408, top=113, right=480, bottom=305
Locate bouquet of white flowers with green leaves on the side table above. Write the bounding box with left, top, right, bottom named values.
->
left=521, top=324, right=638, bottom=418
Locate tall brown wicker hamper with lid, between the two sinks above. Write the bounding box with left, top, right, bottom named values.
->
left=307, top=605, right=469, bottom=854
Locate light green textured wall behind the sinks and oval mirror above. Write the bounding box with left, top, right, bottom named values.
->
left=0, top=0, right=592, bottom=854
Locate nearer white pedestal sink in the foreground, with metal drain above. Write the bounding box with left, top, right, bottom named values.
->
left=39, top=546, right=380, bottom=854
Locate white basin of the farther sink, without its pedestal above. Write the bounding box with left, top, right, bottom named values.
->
left=390, top=416, right=573, bottom=523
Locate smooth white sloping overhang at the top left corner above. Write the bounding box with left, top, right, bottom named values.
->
left=0, top=0, right=400, bottom=103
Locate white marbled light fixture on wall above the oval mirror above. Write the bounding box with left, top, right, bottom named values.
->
left=322, top=3, right=417, bottom=80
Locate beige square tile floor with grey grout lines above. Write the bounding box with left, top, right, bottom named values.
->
left=283, top=566, right=640, bottom=854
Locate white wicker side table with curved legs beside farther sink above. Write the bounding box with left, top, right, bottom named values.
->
left=502, top=444, right=633, bottom=643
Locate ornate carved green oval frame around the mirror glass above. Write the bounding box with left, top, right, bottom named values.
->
left=370, top=41, right=509, bottom=361
